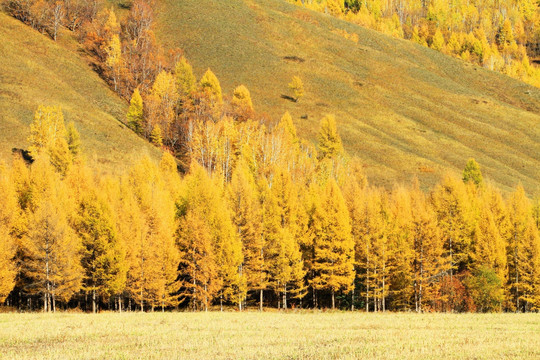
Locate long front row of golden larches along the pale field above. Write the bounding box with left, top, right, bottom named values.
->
left=0, top=107, right=540, bottom=311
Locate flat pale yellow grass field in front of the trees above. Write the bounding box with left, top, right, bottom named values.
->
left=0, top=312, right=540, bottom=359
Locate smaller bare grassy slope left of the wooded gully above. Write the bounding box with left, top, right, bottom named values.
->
left=0, top=13, right=159, bottom=171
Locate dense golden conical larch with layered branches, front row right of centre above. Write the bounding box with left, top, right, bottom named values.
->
left=311, top=179, right=354, bottom=308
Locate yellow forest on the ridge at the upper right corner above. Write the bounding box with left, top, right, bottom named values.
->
left=290, top=0, right=540, bottom=86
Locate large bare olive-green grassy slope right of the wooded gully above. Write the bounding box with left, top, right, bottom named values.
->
left=158, top=0, right=540, bottom=193
